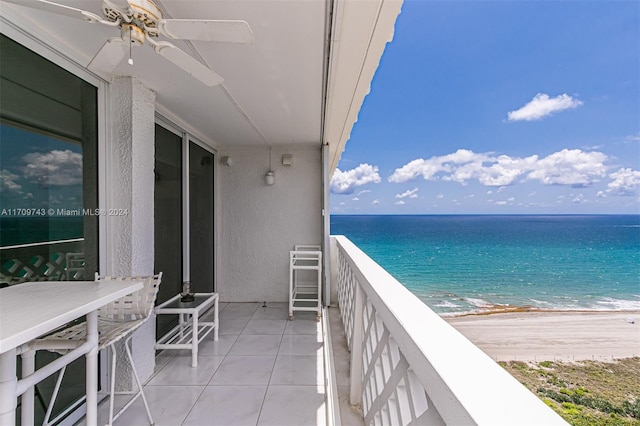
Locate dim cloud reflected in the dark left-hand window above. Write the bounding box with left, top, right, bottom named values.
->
left=22, top=149, right=82, bottom=186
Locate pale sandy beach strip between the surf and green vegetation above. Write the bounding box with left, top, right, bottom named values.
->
left=445, top=311, right=640, bottom=361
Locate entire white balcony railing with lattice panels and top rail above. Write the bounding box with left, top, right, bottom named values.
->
left=331, top=236, right=566, bottom=426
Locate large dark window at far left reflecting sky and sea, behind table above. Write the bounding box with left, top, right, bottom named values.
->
left=0, top=36, right=98, bottom=423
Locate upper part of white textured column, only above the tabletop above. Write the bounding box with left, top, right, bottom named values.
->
left=107, top=77, right=155, bottom=275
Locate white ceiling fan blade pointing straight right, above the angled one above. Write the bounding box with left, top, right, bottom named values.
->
left=158, top=19, right=254, bottom=43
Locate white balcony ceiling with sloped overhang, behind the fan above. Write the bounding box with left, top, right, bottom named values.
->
left=0, top=0, right=401, bottom=167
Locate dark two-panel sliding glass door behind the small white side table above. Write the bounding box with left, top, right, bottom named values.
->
left=154, top=125, right=215, bottom=337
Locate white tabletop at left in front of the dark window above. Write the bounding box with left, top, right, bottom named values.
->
left=0, top=281, right=143, bottom=353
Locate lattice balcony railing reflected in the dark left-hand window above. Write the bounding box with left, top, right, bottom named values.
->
left=0, top=238, right=84, bottom=285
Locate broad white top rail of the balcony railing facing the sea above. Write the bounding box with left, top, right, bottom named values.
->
left=332, top=236, right=566, bottom=425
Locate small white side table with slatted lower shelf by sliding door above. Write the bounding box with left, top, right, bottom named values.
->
left=155, top=293, right=218, bottom=367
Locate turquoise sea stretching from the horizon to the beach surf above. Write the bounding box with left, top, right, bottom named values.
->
left=331, top=215, right=640, bottom=314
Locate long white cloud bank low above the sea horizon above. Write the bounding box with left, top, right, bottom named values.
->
left=389, top=149, right=608, bottom=188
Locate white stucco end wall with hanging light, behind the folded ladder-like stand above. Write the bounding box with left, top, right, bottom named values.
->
left=217, top=146, right=322, bottom=302
